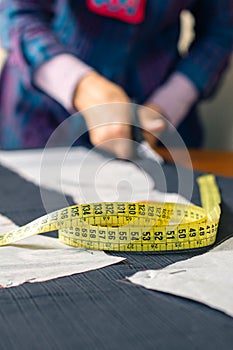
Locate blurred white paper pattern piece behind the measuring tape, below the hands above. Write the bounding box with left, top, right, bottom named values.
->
left=0, top=147, right=188, bottom=203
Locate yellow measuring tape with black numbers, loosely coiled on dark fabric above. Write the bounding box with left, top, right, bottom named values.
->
left=0, top=175, right=220, bottom=252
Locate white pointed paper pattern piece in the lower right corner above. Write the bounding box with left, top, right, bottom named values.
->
left=128, top=238, right=233, bottom=317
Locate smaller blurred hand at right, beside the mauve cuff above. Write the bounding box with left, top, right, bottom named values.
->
left=138, top=104, right=166, bottom=148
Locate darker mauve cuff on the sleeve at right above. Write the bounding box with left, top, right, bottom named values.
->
left=147, top=72, right=198, bottom=127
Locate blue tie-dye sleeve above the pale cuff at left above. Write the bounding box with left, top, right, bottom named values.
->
left=0, top=0, right=72, bottom=74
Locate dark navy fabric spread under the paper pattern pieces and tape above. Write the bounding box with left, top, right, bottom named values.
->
left=0, top=159, right=233, bottom=350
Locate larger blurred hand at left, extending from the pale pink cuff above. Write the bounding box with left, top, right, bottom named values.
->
left=73, top=72, right=132, bottom=159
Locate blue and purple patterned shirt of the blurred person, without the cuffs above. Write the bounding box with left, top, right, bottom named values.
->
left=0, top=0, right=233, bottom=149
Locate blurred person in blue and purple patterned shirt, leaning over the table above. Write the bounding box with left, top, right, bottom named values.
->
left=0, top=0, right=233, bottom=153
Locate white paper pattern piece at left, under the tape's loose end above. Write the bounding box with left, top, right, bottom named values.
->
left=0, top=216, right=124, bottom=288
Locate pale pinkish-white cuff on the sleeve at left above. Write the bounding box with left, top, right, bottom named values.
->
left=34, top=54, right=93, bottom=113
